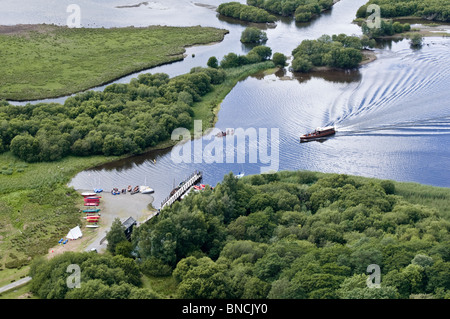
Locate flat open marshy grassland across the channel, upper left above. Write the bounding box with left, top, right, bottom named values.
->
left=0, top=25, right=228, bottom=101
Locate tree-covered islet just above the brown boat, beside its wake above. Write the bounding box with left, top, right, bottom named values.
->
left=292, top=34, right=375, bottom=72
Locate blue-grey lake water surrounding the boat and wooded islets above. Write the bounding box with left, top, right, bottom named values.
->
left=0, top=0, right=450, bottom=207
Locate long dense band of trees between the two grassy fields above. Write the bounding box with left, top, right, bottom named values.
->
left=0, top=68, right=225, bottom=162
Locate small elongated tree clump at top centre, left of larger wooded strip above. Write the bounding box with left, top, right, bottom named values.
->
left=217, top=2, right=277, bottom=23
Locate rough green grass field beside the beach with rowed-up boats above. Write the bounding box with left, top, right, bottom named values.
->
left=0, top=152, right=116, bottom=278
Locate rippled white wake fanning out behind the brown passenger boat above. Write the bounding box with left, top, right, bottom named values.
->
left=327, top=42, right=450, bottom=134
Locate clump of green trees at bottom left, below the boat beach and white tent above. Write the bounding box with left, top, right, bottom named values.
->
left=30, top=252, right=159, bottom=299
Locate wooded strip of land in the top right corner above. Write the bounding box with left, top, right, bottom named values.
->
left=356, top=0, right=450, bottom=22
